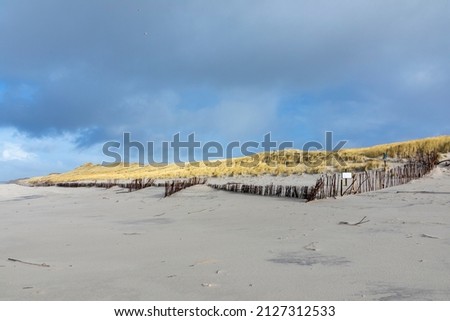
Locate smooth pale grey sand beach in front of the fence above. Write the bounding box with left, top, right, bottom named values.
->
left=0, top=168, right=450, bottom=300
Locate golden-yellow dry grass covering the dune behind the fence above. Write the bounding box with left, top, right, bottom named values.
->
left=28, top=136, right=450, bottom=184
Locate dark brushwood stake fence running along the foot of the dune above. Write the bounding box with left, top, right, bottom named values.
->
left=31, top=153, right=438, bottom=201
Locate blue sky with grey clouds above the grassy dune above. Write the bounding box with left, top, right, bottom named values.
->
left=0, top=0, right=450, bottom=181
